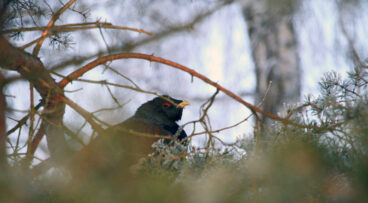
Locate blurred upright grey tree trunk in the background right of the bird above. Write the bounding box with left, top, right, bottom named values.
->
left=243, top=1, right=301, bottom=134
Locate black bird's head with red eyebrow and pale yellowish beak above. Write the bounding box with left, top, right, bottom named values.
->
left=135, top=95, right=189, bottom=123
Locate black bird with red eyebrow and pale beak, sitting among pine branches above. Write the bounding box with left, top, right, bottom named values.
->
left=76, top=95, right=189, bottom=174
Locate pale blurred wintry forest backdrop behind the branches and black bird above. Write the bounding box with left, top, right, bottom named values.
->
left=6, top=0, right=368, bottom=159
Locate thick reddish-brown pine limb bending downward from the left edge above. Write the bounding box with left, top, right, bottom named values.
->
left=0, top=37, right=68, bottom=163
